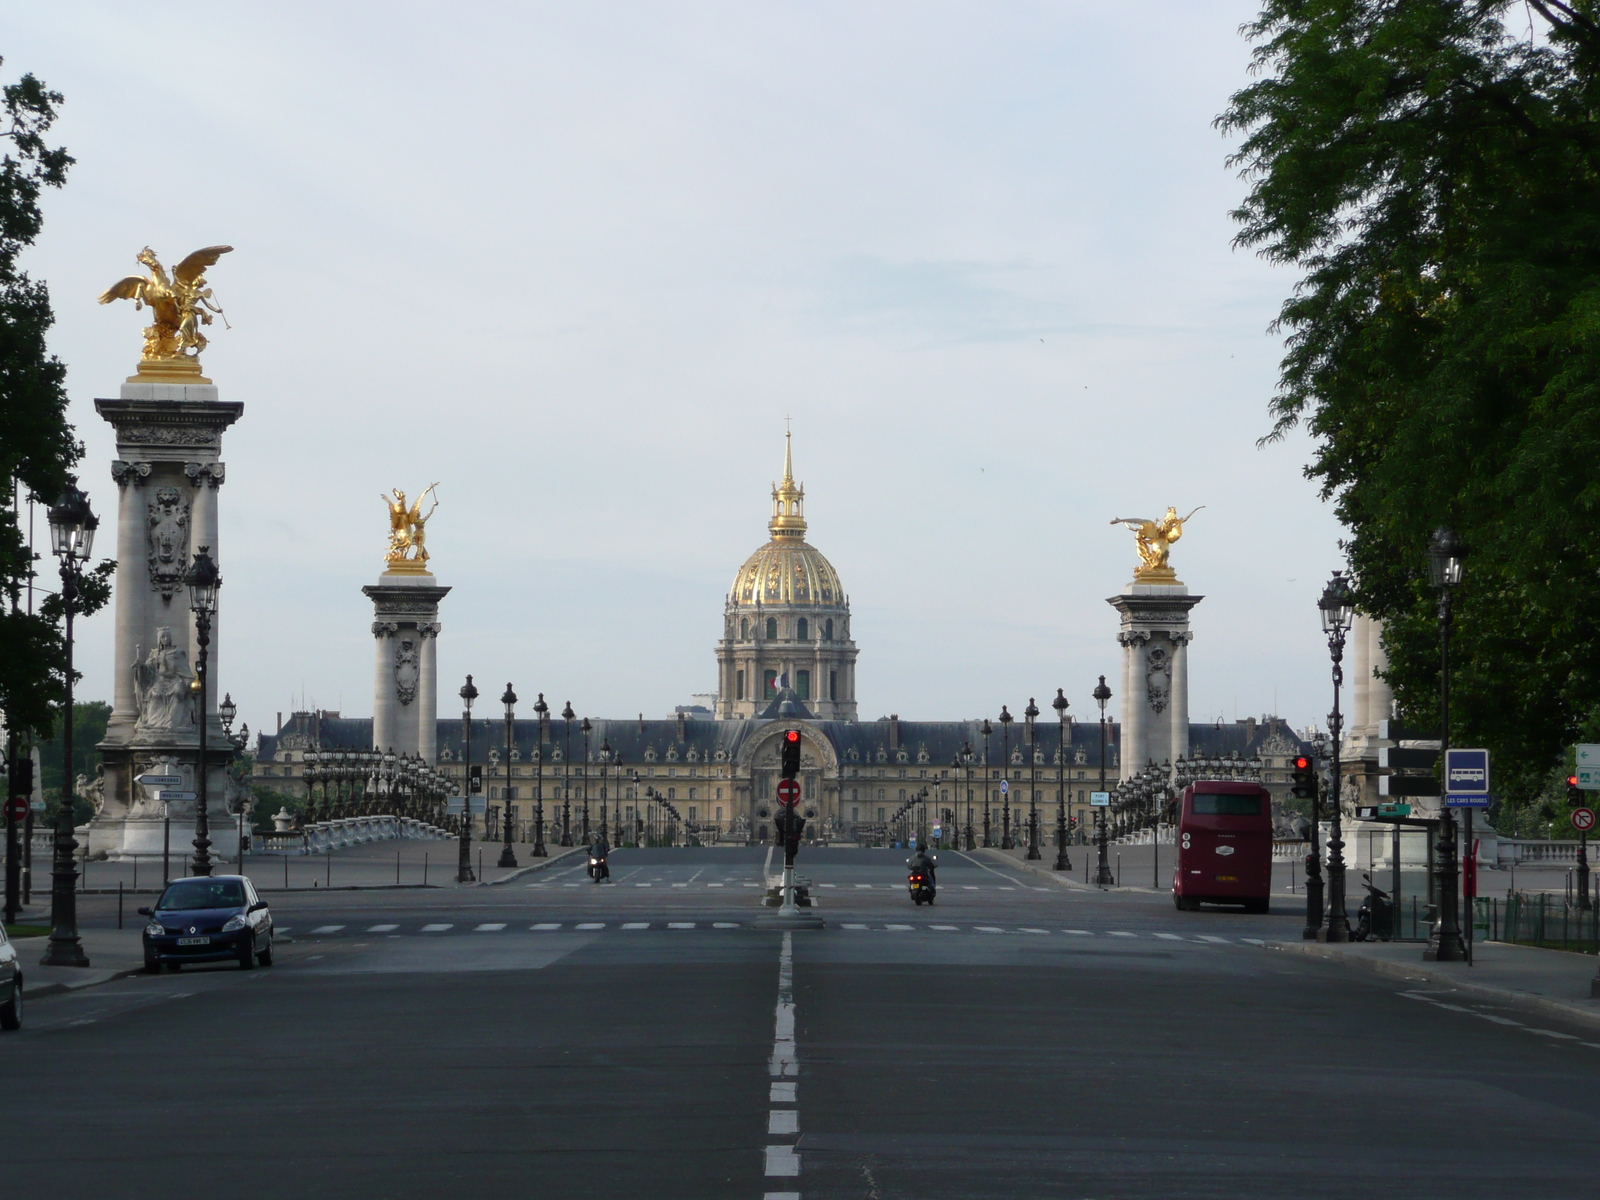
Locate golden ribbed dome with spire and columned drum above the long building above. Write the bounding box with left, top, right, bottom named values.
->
left=717, top=434, right=856, bottom=722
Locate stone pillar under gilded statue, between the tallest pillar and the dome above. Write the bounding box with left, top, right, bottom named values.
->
left=362, top=570, right=450, bottom=763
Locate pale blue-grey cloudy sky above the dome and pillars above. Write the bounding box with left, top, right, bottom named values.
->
left=9, top=0, right=1342, bottom=742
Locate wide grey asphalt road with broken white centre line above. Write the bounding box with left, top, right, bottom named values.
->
left=0, top=850, right=1600, bottom=1200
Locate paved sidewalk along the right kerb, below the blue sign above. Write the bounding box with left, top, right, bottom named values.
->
left=1267, top=941, right=1600, bottom=1027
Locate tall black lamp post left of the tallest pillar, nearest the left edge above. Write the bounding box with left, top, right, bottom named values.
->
left=40, top=478, right=99, bottom=972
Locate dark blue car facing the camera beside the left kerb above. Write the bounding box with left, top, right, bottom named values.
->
left=139, top=875, right=272, bottom=973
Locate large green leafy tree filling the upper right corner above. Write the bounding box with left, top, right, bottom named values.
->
left=1218, top=0, right=1600, bottom=800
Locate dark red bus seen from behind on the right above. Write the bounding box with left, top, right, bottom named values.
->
left=1173, top=779, right=1272, bottom=912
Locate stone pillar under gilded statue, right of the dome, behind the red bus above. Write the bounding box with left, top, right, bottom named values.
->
left=1106, top=579, right=1205, bottom=779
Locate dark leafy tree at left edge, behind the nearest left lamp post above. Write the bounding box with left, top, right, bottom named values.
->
left=0, top=59, right=112, bottom=748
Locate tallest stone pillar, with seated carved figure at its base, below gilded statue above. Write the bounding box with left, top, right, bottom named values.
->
left=88, top=376, right=245, bottom=872
